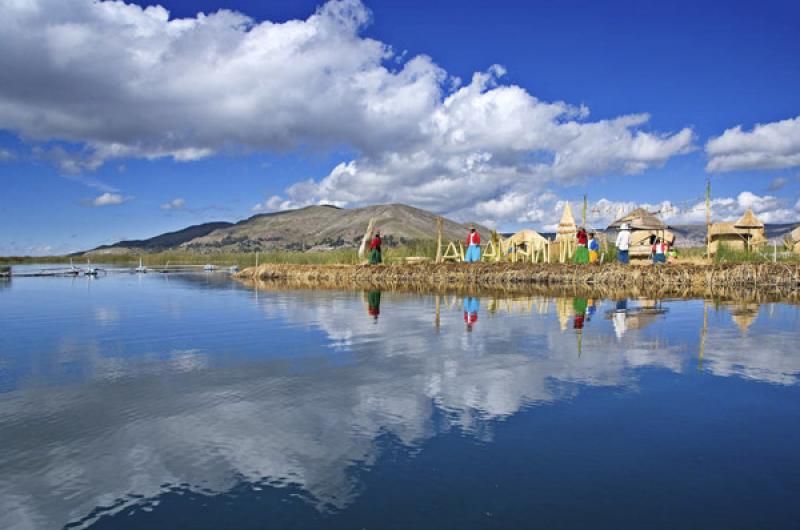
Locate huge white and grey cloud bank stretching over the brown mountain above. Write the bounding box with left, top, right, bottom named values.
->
left=0, top=0, right=694, bottom=221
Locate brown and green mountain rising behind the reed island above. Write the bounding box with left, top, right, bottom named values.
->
left=87, top=204, right=489, bottom=254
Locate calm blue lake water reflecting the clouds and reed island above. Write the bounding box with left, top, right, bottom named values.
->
left=0, top=274, right=800, bottom=530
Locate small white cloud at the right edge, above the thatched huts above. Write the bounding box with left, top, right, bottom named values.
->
left=706, top=116, right=800, bottom=172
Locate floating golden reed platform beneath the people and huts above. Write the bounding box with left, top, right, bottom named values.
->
left=236, top=263, right=800, bottom=301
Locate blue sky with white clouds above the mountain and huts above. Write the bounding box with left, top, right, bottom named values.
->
left=0, top=0, right=800, bottom=254
